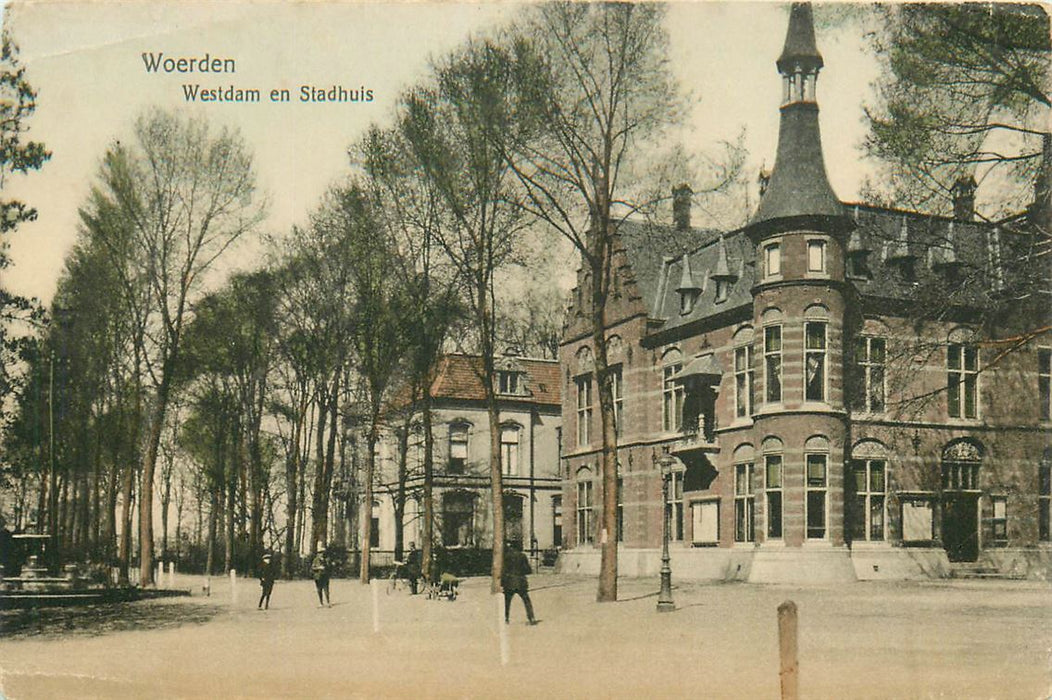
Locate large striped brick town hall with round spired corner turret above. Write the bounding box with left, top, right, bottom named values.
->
left=560, top=3, right=1052, bottom=581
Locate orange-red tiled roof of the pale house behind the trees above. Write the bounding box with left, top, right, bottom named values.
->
left=431, top=355, right=562, bottom=407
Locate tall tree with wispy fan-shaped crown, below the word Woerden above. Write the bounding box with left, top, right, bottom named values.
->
left=91, top=109, right=262, bottom=585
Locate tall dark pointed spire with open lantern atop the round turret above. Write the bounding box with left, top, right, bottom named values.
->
left=750, top=3, right=844, bottom=225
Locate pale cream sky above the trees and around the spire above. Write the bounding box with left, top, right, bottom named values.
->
left=4, top=0, right=876, bottom=303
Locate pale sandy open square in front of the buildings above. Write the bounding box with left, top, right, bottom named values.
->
left=0, top=575, right=1052, bottom=700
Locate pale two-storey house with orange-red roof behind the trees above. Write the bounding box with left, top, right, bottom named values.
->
left=372, top=355, right=562, bottom=559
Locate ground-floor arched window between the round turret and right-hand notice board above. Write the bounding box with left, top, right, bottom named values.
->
left=845, top=440, right=888, bottom=542
